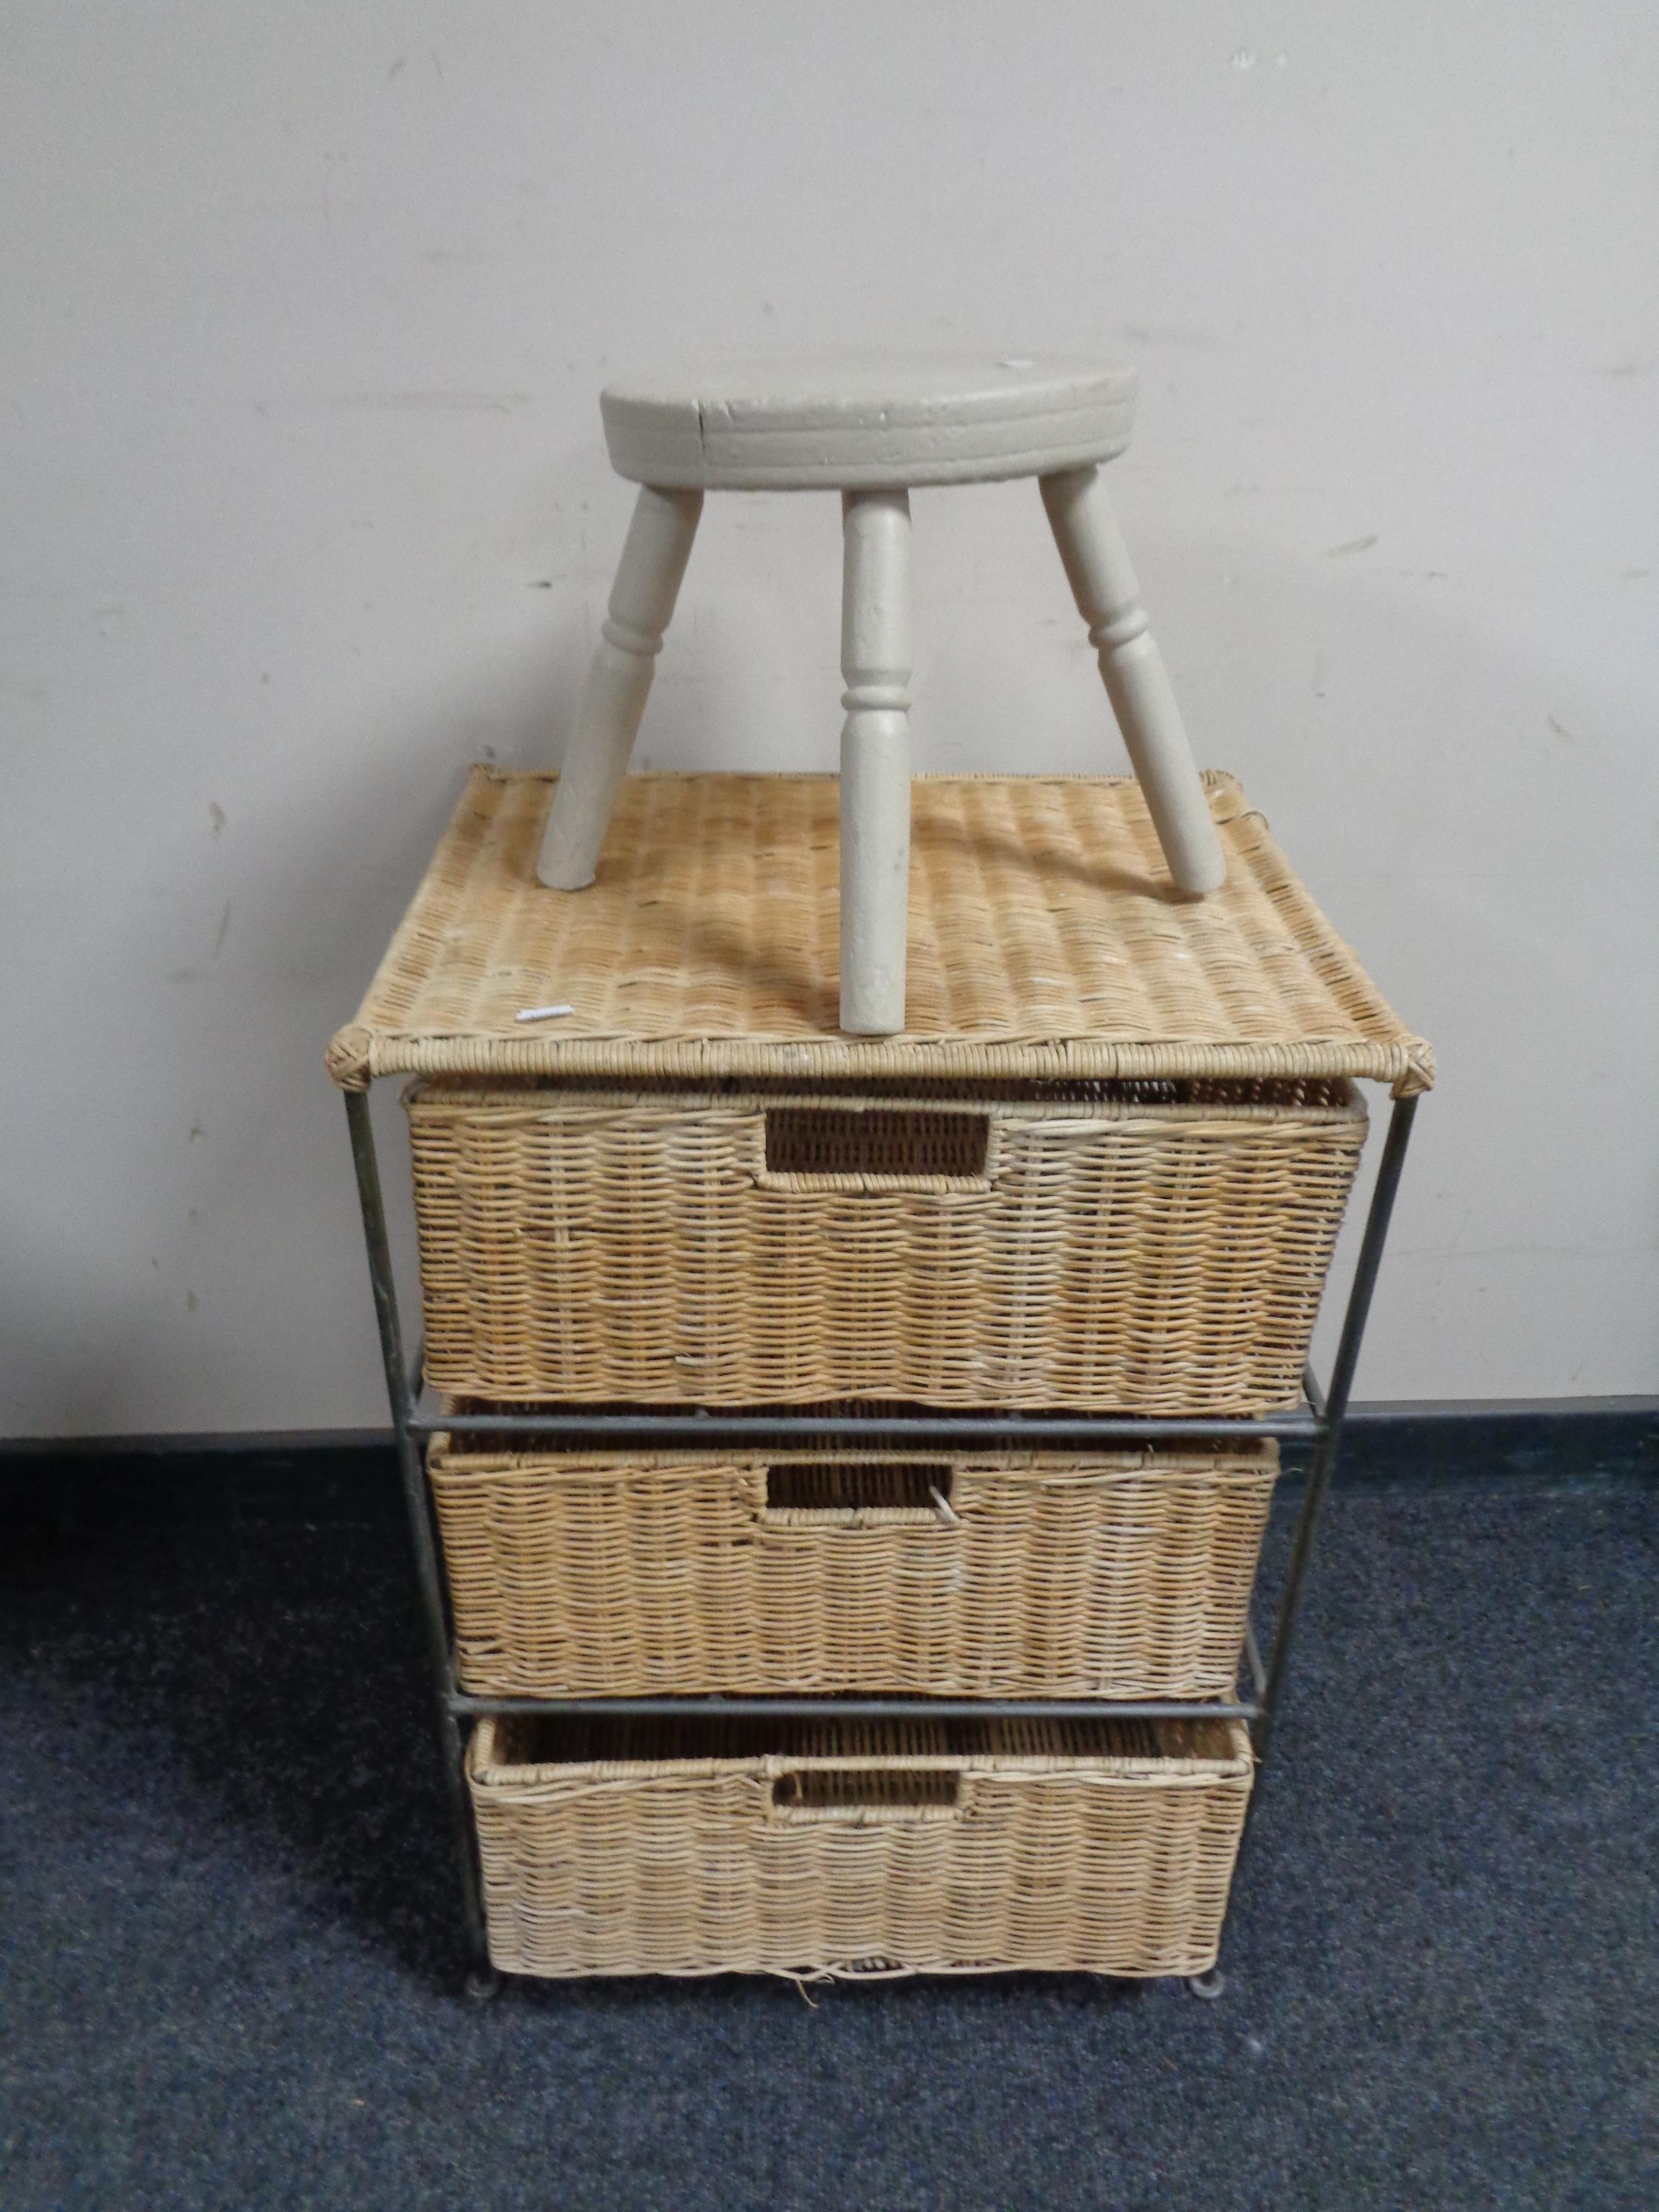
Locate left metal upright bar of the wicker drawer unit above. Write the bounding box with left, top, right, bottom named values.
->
left=345, top=1091, right=500, bottom=1995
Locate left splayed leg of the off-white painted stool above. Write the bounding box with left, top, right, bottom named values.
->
left=535, top=484, right=703, bottom=891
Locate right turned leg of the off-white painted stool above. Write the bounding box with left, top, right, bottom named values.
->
left=1042, top=469, right=1228, bottom=891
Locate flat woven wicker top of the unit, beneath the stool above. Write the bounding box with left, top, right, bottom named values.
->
left=327, top=768, right=1433, bottom=1095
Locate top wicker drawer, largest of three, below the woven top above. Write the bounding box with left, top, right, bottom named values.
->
left=409, top=1082, right=1365, bottom=1413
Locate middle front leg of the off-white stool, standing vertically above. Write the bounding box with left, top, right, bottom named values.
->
left=841, top=491, right=909, bottom=1037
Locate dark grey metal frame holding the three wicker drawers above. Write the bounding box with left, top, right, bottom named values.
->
left=345, top=1091, right=1418, bottom=1995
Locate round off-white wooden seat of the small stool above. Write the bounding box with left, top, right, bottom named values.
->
left=599, top=354, right=1135, bottom=491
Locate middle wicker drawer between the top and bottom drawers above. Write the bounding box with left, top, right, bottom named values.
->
left=429, top=1438, right=1279, bottom=1699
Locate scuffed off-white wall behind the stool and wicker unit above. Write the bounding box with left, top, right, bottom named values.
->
left=0, top=0, right=1659, bottom=1433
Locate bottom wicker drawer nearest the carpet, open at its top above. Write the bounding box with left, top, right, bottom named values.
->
left=467, top=1717, right=1252, bottom=1975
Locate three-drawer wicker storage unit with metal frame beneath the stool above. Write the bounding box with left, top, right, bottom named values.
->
left=327, top=768, right=1433, bottom=1995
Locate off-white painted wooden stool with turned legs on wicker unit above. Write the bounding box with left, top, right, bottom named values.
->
left=538, top=354, right=1225, bottom=1037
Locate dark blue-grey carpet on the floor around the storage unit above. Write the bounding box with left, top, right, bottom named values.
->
left=0, top=1489, right=1659, bottom=2212
